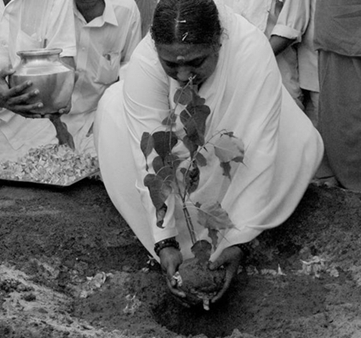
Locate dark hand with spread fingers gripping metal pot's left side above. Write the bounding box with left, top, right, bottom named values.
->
left=0, top=69, right=43, bottom=118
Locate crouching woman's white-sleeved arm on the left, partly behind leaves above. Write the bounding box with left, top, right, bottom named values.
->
left=123, top=35, right=178, bottom=242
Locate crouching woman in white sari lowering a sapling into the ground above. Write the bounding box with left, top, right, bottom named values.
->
left=95, top=0, right=323, bottom=302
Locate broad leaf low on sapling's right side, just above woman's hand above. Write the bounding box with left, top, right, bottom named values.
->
left=198, top=202, right=234, bottom=230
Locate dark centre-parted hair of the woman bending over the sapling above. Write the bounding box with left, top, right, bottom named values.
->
left=151, top=0, right=222, bottom=45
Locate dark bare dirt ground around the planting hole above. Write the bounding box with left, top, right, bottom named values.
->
left=0, top=179, right=361, bottom=338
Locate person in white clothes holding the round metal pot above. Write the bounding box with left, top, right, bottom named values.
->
left=0, top=0, right=76, bottom=161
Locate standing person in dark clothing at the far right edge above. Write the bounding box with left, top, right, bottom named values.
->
left=315, top=0, right=361, bottom=192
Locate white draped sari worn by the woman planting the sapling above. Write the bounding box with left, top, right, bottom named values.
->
left=95, top=1, right=323, bottom=260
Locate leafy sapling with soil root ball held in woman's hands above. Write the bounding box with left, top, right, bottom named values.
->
left=140, top=78, right=244, bottom=309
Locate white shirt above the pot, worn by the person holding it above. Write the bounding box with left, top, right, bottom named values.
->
left=0, top=0, right=76, bottom=68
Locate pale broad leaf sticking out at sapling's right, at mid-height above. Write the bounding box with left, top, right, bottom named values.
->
left=214, top=134, right=244, bottom=162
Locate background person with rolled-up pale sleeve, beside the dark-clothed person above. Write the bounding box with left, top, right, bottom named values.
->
left=270, top=0, right=319, bottom=127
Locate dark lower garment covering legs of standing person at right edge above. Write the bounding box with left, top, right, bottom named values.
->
left=319, top=51, right=361, bottom=191
